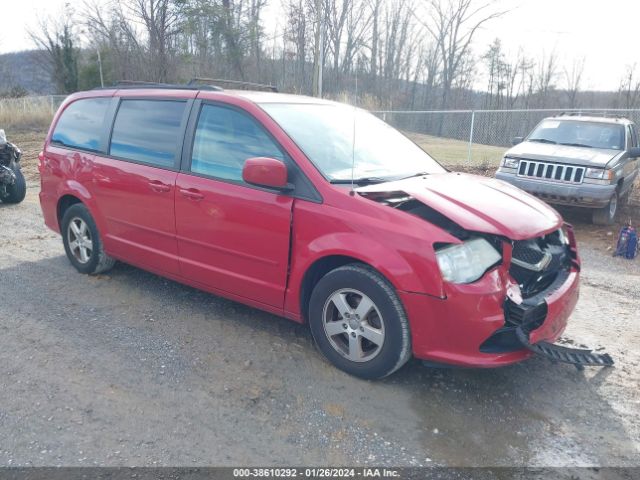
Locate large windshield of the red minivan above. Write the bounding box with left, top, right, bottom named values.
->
left=261, top=103, right=445, bottom=183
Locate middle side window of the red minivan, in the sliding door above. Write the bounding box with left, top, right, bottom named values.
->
left=109, top=100, right=186, bottom=167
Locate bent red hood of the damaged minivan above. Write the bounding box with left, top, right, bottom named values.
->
left=356, top=172, right=562, bottom=240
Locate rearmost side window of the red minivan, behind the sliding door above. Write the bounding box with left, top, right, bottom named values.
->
left=51, top=97, right=111, bottom=151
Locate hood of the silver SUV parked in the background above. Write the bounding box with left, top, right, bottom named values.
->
left=505, top=142, right=622, bottom=168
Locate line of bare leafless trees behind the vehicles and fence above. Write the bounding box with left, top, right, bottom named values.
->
left=11, top=0, right=640, bottom=110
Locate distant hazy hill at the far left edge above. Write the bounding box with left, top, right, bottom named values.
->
left=0, top=50, right=55, bottom=95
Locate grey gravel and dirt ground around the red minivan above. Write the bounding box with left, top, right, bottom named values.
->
left=0, top=132, right=640, bottom=467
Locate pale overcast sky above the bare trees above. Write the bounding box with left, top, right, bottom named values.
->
left=0, top=0, right=640, bottom=90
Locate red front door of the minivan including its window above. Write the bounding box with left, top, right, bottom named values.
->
left=175, top=104, right=293, bottom=308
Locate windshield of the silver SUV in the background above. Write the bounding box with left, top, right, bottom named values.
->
left=527, top=120, right=624, bottom=150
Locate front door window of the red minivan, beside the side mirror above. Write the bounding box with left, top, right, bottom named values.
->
left=191, top=105, right=284, bottom=181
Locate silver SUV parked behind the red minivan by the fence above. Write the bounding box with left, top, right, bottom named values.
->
left=496, top=114, right=640, bottom=225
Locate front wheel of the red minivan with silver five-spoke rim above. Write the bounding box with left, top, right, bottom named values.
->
left=309, top=263, right=411, bottom=380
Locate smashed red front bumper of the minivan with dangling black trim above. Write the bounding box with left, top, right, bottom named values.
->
left=400, top=225, right=613, bottom=367
